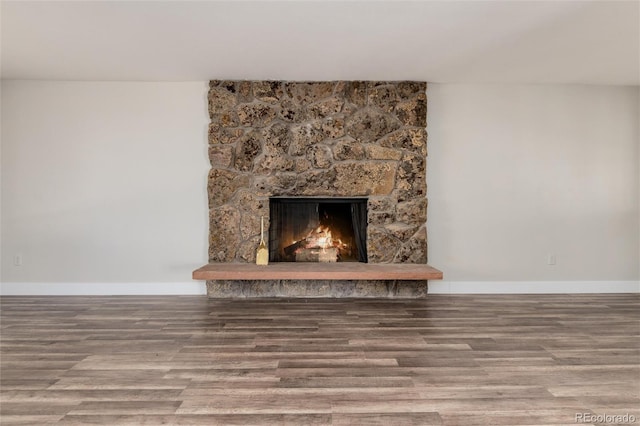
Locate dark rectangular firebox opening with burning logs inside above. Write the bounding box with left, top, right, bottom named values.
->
left=269, top=198, right=367, bottom=263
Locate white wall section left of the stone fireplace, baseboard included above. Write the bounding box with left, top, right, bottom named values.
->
left=1, top=81, right=209, bottom=294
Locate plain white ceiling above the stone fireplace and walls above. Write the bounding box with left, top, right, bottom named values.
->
left=0, top=0, right=640, bottom=85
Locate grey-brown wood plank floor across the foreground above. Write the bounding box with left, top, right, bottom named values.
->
left=0, top=294, right=640, bottom=426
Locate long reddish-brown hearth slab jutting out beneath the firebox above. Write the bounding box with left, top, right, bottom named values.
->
left=193, top=262, right=442, bottom=280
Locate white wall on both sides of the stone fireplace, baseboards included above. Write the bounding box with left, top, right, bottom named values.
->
left=0, top=81, right=640, bottom=294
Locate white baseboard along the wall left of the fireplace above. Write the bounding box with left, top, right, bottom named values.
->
left=0, top=281, right=207, bottom=296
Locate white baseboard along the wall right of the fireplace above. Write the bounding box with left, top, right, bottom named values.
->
left=429, top=280, right=640, bottom=294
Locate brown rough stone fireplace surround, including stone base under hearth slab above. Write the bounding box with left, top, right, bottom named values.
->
left=207, top=80, right=427, bottom=297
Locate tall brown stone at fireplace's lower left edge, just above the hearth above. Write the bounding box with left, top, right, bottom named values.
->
left=209, top=206, right=241, bottom=262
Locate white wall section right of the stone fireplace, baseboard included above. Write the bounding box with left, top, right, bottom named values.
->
left=427, top=84, right=640, bottom=292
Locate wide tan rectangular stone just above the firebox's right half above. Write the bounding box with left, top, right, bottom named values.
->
left=335, top=162, right=396, bottom=196
